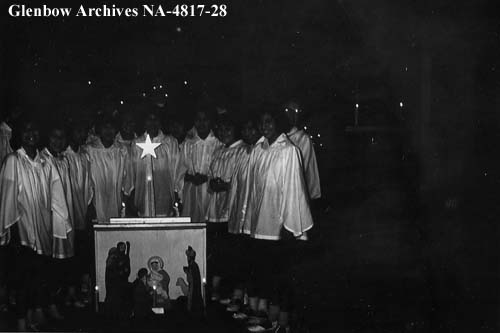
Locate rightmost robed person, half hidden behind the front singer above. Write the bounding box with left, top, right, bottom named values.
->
left=285, top=102, right=321, bottom=200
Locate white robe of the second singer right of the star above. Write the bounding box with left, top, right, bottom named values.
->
left=205, top=140, right=246, bottom=222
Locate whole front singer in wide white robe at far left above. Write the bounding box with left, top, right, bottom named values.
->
left=0, top=121, right=71, bottom=331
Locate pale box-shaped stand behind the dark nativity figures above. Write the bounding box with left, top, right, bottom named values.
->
left=94, top=217, right=206, bottom=302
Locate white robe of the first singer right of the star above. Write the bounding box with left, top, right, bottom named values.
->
left=177, top=128, right=223, bottom=222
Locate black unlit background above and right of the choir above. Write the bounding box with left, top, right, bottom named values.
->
left=0, top=0, right=500, bottom=332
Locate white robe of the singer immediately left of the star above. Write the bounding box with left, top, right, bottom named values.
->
left=83, top=137, right=128, bottom=223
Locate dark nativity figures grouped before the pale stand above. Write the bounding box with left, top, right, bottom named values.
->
left=104, top=241, right=204, bottom=320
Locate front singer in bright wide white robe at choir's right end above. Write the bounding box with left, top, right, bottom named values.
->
left=243, top=106, right=313, bottom=307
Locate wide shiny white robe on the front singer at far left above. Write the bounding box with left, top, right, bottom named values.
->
left=0, top=148, right=71, bottom=257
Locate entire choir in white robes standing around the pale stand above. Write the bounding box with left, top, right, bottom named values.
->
left=0, top=102, right=321, bottom=330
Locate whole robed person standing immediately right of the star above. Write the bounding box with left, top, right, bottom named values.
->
left=177, top=111, right=222, bottom=222
